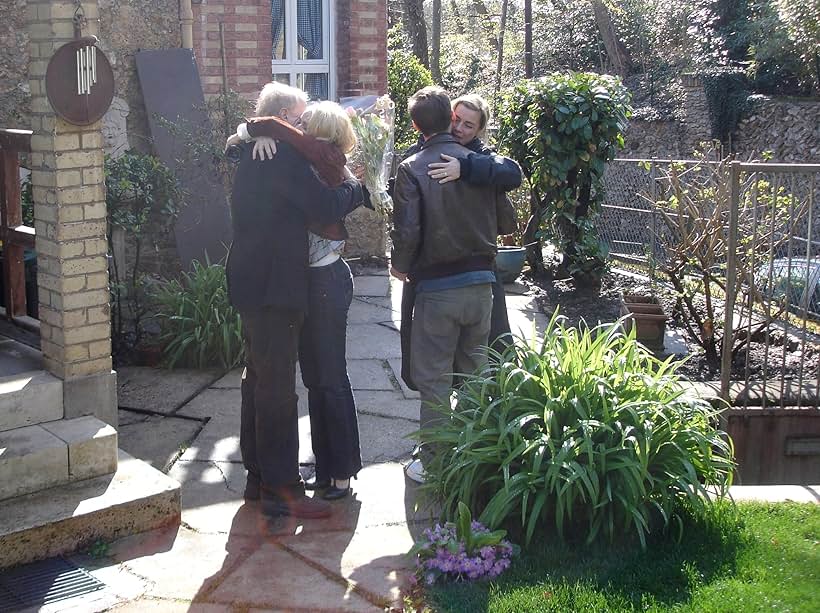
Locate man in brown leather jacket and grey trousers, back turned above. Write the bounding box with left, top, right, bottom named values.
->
left=390, top=87, right=512, bottom=481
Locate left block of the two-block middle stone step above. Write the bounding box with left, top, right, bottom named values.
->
left=0, top=426, right=68, bottom=500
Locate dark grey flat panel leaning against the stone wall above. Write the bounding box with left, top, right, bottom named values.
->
left=136, top=49, right=231, bottom=268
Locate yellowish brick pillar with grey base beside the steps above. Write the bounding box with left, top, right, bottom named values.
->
left=27, top=0, right=117, bottom=426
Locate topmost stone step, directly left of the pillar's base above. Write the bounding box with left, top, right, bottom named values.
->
left=0, top=370, right=63, bottom=432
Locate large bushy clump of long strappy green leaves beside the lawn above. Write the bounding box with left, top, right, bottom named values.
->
left=420, top=313, right=734, bottom=545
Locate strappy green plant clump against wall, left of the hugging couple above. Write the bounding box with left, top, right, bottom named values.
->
left=154, top=260, right=244, bottom=369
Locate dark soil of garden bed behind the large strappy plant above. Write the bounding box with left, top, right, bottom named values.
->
left=519, top=269, right=820, bottom=381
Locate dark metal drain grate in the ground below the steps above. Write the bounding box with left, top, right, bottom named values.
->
left=0, top=558, right=105, bottom=612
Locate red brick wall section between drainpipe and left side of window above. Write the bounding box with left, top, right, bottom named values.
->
left=193, top=0, right=271, bottom=96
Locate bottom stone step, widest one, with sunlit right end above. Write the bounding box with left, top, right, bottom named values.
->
left=0, top=451, right=180, bottom=569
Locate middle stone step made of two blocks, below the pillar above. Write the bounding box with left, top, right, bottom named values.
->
left=0, top=416, right=117, bottom=500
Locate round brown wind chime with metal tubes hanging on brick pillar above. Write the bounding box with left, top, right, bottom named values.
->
left=46, top=0, right=114, bottom=126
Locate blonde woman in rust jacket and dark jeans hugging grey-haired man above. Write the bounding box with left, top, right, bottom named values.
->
left=238, top=102, right=369, bottom=500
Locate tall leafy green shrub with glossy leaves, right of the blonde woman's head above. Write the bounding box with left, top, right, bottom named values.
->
left=499, top=73, right=631, bottom=279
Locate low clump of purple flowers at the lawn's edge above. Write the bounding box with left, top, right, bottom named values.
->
left=410, top=502, right=518, bottom=585
